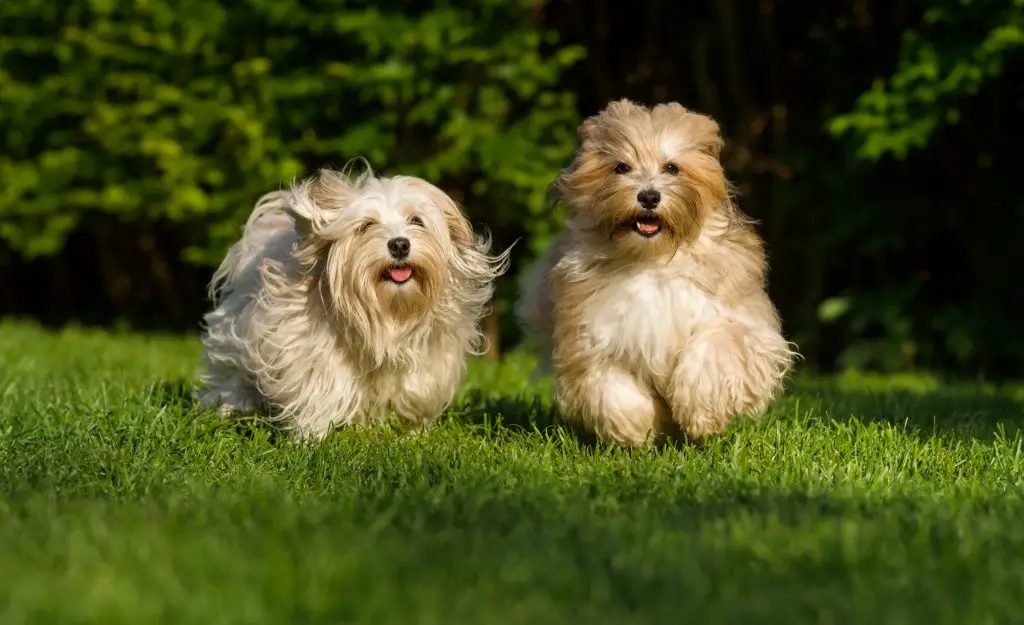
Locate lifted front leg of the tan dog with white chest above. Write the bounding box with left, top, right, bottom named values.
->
left=665, top=319, right=791, bottom=439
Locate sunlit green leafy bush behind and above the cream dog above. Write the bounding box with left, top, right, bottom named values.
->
left=0, top=0, right=583, bottom=263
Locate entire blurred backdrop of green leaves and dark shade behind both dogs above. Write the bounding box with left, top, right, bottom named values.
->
left=0, top=0, right=1024, bottom=375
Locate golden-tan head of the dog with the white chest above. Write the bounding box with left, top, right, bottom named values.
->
left=552, top=99, right=730, bottom=259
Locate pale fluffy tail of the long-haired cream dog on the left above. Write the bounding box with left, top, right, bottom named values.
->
left=209, top=191, right=295, bottom=303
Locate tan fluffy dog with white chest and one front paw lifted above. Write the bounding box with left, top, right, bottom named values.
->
left=518, top=100, right=796, bottom=445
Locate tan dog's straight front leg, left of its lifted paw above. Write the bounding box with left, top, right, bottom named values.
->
left=555, top=363, right=669, bottom=446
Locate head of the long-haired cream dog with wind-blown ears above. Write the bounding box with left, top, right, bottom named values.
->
left=280, top=169, right=508, bottom=358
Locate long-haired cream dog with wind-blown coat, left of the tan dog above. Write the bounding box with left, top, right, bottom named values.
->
left=199, top=165, right=508, bottom=438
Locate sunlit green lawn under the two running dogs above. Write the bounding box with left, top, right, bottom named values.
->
left=0, top=324, right=1024, bottom=625
